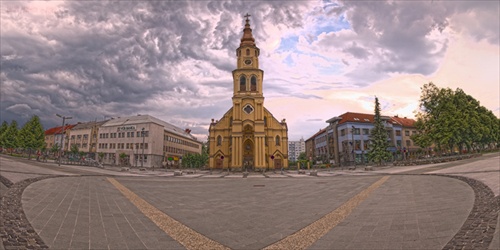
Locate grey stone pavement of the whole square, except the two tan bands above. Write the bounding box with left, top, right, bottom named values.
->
left=0, top=155, right=500, bottom=249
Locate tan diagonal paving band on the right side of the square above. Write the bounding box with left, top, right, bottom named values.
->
left=264, top=176, right=389, bottom=250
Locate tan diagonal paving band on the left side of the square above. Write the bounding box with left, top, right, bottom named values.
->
left=107, top=178, right=229, bottom=249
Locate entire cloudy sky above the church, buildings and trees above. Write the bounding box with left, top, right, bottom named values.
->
left=0, top=0, right=500, bottom=140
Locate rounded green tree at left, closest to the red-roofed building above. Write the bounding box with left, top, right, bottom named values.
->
left=18, top=115, right=45, bottom=159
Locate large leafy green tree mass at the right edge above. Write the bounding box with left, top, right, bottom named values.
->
left=413, top=82, right=500, bottom=153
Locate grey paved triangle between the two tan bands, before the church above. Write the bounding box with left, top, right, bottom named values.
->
left=116, top=176, right=381, bottom=249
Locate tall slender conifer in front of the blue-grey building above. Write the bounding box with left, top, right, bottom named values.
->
left=368, top=97, right=391, bottom=165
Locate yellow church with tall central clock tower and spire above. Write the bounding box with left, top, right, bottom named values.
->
left=209, top=14, right=288, bottom=171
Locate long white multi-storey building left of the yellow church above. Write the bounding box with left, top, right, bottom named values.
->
left=97, top=115, right=202, bottom=167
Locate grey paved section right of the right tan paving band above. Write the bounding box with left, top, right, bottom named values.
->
left=310, top=176, right=474, bottom=250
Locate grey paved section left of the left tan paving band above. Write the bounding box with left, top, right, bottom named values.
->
left=23, top=177, right=183, bottom=249
